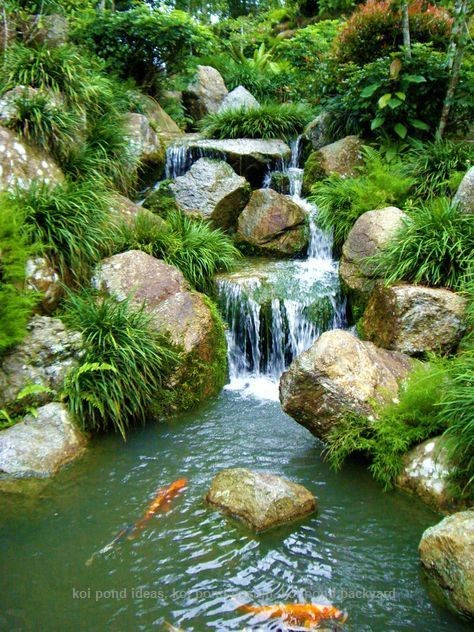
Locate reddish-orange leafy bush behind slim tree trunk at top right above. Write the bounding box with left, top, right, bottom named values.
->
left=337, top=0, right=452, bottom=66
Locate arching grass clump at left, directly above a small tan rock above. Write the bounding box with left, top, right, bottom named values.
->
left=10, top=180, right=110, bottom=282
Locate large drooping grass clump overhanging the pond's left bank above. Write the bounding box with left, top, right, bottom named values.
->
left=62, top=292, right=179, bottom=438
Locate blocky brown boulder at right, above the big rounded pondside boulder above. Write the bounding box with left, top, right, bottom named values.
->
left=362, top=283, right=466, bottom=356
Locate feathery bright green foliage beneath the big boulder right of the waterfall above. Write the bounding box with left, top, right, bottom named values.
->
left=326, top=363, right=446, bottom=489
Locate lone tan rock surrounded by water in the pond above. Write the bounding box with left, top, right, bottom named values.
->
left=206, top=468, right=317, bottom=531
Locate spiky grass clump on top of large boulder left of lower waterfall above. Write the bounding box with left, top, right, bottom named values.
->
left=115, top=211, right=240, bottom=291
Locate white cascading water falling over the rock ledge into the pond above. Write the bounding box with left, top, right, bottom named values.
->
left=217, top=138, right=345, bottom=399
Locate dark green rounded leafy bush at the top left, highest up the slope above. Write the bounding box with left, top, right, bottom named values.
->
left=75, top=4, right=214, bottom=94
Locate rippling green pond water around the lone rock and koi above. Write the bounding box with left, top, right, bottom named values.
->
left=0, top=390, right=468, bottom=632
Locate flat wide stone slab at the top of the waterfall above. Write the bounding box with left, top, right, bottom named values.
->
left=186, top=138, right=291, bottom=188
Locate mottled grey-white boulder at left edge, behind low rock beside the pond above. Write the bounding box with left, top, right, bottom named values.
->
left=0, top=316, right=83, bottom=413
